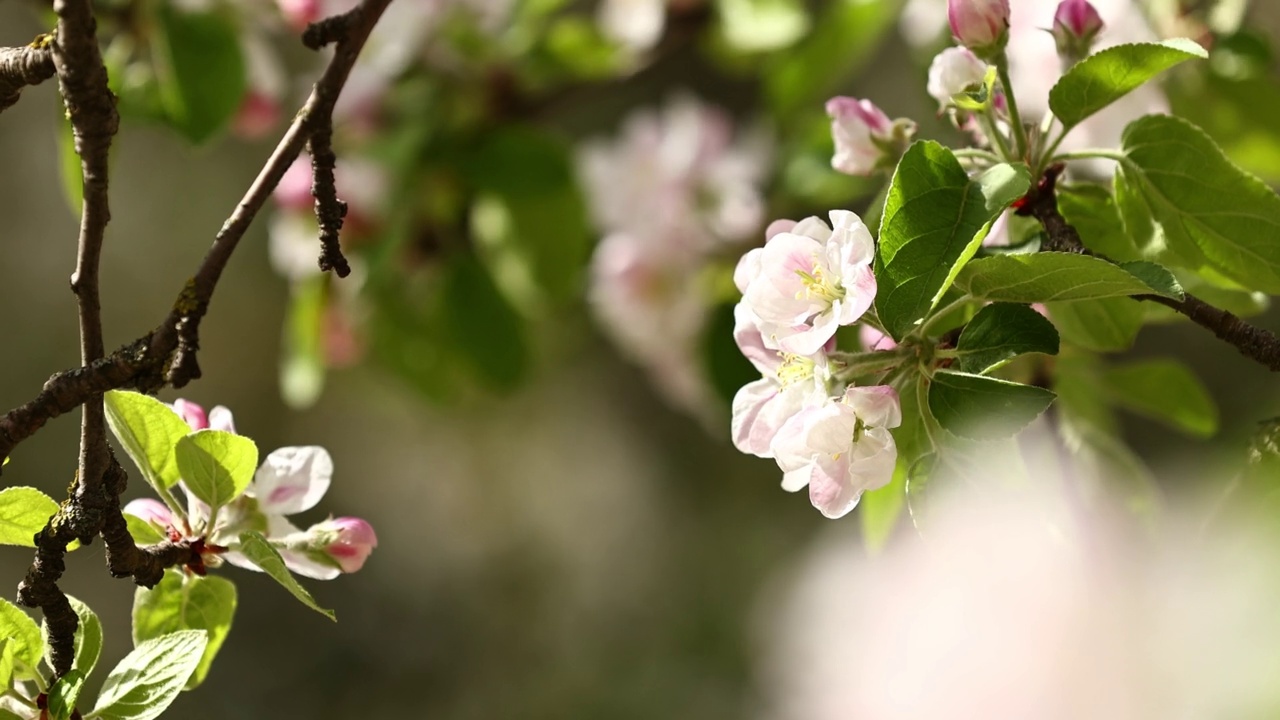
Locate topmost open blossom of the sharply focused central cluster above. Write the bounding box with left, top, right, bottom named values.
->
left=735, top=210, right=876, bottom=355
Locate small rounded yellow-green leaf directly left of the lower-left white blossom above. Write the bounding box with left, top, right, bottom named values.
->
left=175, top=430, right=257, bottom=516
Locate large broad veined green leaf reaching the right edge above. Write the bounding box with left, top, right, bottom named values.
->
left=1121, top=115, right=1280, bottom=295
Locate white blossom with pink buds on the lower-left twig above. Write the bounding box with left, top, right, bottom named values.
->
left=124, top=400, right=378, bottom=580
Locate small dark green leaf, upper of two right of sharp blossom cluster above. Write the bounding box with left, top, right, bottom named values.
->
left=956, top=302, right=1057, bottom=375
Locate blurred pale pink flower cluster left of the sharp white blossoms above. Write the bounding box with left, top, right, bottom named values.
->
left=580, top=96, right=769, bottom=414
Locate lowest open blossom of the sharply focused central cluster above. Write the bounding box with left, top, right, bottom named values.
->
left=772, top=386, right=902, bottom=519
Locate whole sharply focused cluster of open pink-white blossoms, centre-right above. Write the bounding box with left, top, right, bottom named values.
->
left=732, top=210, right=902, bottom=518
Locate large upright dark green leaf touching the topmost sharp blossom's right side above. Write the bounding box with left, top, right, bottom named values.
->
left=876, top=141, right=1030, bottom=340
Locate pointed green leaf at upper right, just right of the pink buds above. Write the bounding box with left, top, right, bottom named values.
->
left=1048, top=37, right=1208, bottom=128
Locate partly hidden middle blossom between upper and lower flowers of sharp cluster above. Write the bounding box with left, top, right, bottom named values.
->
left=731, top=304, right=831, bottom=457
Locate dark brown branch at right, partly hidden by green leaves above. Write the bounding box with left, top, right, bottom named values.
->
left=1018, top=164, right=1280, bottom=372
